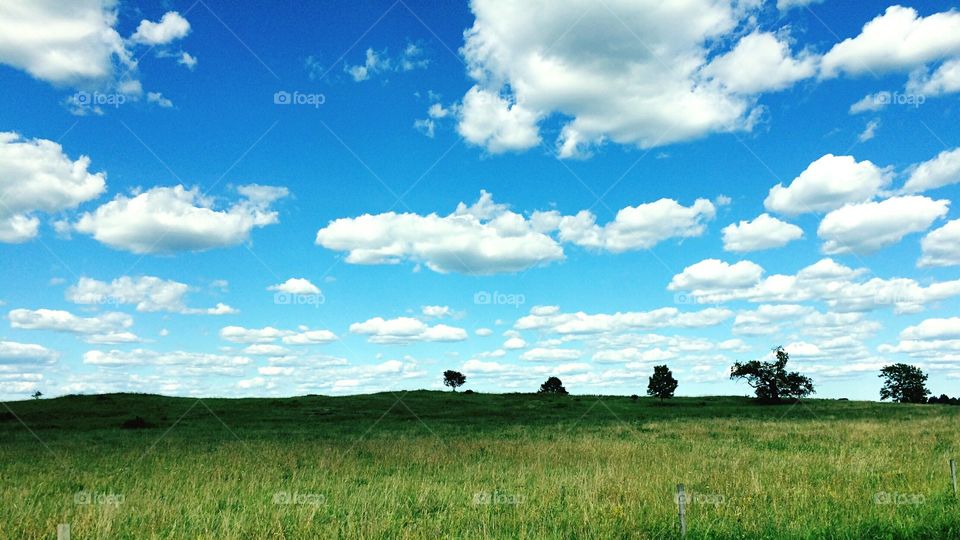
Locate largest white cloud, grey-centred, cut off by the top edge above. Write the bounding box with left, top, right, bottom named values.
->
left=460, top=0, right=764, bottom=157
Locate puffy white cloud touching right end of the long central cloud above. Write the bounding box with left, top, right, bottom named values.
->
left=559, top=199, right=716, bottom=253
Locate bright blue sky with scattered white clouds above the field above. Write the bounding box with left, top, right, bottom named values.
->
left=0, top=0, right=960, bottom=399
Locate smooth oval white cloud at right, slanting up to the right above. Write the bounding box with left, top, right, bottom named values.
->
left=817, top=195, right=950, bottom=254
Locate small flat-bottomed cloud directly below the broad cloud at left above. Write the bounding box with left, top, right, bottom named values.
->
left=66, top=276, right=236, bottom=315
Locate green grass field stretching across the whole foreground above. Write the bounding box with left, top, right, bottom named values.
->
left=0, top=391, right=960, bottom=539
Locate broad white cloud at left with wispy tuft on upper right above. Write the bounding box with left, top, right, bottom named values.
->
left=74, top=185, right=287, bottom=254
